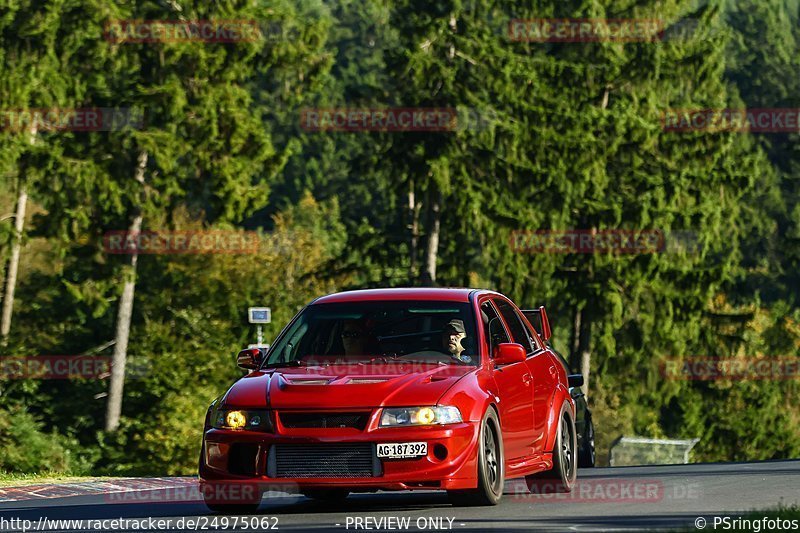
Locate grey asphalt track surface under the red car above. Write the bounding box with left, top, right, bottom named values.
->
left=0, top=460, right=800, bottom=532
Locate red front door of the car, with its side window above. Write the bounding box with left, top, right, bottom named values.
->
left=480, top=300, right=533, bottom=460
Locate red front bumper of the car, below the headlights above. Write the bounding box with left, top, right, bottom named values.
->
left=200, top=415, right=478, bottom=492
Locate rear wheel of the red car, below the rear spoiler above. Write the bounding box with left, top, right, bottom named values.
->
left=525, top=402, right=578, bottom=494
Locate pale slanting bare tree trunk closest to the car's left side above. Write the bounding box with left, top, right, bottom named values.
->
left=105, top=151, right=147, bottom=431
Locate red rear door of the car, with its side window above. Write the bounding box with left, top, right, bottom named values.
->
left=496, top=300, right=557, bottom=453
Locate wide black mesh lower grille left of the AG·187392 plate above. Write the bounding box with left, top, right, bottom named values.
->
left=267, top=442, right=382, bottom=478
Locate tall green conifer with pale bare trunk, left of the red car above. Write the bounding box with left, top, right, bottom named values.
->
left=26, top=2, right=332, bottom=430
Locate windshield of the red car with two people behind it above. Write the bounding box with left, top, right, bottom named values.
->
left=266, top=301, right=478, bottom=366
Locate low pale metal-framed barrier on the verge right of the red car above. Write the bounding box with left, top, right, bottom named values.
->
left=608, top=437, right=700, bottom=466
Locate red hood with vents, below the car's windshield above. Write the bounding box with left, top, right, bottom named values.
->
left=223, top=364, right=477, bottom=409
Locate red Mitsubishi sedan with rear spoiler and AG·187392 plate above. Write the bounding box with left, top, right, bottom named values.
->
left=200, top=288, right=576, bottom=512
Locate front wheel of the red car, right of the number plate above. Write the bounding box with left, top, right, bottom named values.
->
left=447, top=408, right=505, bottom=506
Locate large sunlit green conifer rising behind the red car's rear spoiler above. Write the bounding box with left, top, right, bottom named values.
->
left=376, top=1, right=770, bottom=458
